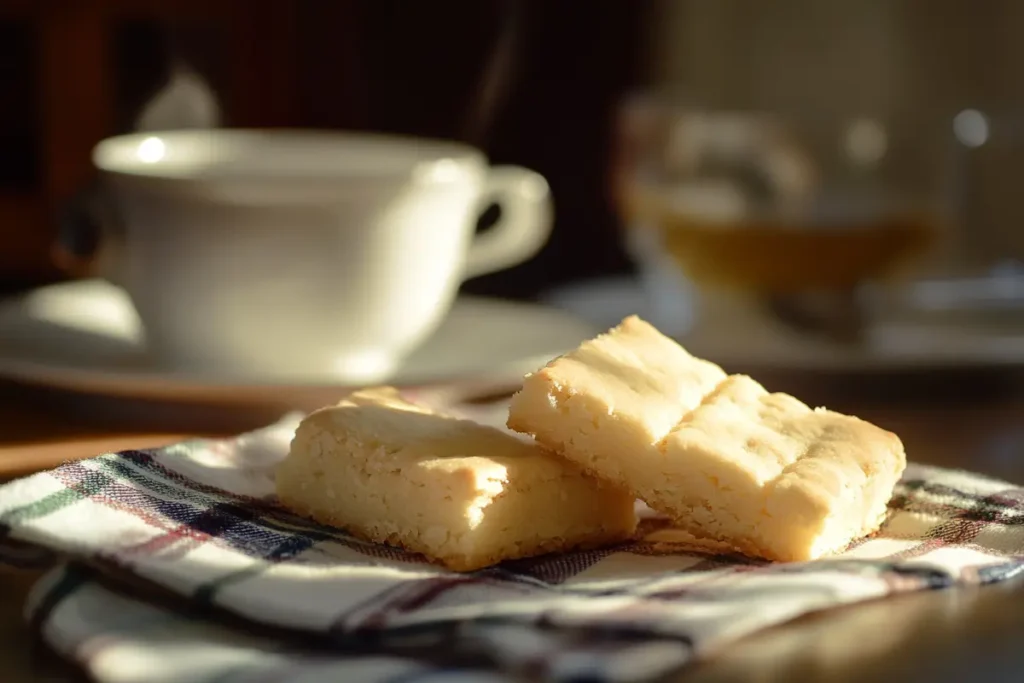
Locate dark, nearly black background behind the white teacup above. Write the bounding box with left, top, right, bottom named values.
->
left=0, top=0, right=651, bottom=297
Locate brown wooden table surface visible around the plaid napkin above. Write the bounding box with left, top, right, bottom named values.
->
left=0, top=382, right=1024, bottom=683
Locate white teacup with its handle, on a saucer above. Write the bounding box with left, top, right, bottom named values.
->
left=64, top=129, right=552, bottom=383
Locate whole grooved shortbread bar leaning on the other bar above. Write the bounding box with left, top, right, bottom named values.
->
left=508, top=318, right=906, bottom=561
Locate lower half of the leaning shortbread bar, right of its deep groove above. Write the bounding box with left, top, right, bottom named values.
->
left=645, top=375, right=906, bottom=561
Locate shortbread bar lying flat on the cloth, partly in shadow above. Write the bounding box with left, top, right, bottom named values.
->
left=276, top=387, right=637, bottom=571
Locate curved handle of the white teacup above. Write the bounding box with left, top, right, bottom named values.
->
left=463, top=166, right=554, bottom=280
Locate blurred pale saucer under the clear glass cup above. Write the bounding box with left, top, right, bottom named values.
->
left=542, top=278, right=1024, bottom=373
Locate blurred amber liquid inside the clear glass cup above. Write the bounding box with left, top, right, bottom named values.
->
left=625, top=184, right=937, bottom=294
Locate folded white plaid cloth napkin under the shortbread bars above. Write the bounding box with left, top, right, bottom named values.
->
left=0, top=405, right=1024, bottom=683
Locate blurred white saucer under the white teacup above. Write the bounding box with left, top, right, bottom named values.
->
left=0, top=280, right=595, bottom=405
